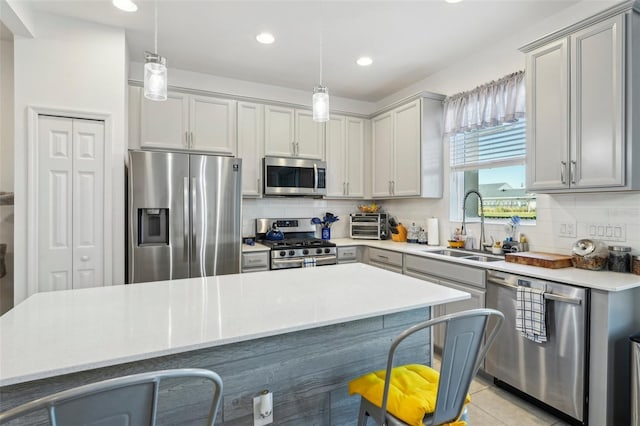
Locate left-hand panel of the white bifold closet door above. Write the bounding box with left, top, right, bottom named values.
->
left=37, top=115, right=73, bottom=291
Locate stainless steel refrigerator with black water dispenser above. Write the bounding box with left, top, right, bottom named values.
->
left=127, top=151, right=242, bottom=283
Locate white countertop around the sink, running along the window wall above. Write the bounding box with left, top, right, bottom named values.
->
left=331, top=238, right=640, bottom=292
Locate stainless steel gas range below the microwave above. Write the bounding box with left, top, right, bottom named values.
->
left=256, top=218, right=337, bottom=269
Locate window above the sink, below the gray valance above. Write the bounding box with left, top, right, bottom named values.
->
left=450, top=120, right=536, bottom=220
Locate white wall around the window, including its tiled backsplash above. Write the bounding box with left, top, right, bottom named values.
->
left=370, top=1, right=640, bottom=253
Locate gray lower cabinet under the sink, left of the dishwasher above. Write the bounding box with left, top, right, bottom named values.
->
left=403, top=255, right=486, bottom=351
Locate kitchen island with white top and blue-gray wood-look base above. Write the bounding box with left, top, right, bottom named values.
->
left=0, top=264, right=469, bottom=424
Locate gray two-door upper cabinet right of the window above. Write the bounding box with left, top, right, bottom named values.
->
left=521, top=3, right=640, bottom=192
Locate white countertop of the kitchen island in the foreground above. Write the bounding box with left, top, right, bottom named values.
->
left=0, top=263, right=469, bottom=386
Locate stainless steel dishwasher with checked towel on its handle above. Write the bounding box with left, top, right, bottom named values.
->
left=485, top=271, right=589, bottom=424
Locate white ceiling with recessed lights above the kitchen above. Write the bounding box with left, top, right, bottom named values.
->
left=22, top=0, right=577, bottom=102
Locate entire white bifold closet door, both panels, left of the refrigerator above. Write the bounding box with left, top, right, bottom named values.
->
left=37, top=115, right=105, bottom=291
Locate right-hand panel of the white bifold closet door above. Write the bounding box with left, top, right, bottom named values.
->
left=72, top=120, right=105, bottom=288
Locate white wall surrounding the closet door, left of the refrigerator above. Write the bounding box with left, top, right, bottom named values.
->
left=14, top=10, right=127, bottom=302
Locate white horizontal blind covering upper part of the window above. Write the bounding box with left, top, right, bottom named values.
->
left=450, top=120, right=527, bottom=171
